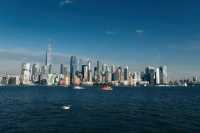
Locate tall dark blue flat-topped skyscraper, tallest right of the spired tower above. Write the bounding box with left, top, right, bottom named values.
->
left=70, top=56, right=78, bottom=84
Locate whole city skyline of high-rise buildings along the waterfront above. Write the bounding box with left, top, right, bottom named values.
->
left=16, top=45, right=169, bottom=86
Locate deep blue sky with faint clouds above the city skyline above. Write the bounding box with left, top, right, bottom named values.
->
left=0, top=0, right=200, bottom=79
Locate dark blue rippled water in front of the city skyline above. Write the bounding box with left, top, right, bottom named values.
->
left=0, top=87, right=200, bottom=133
